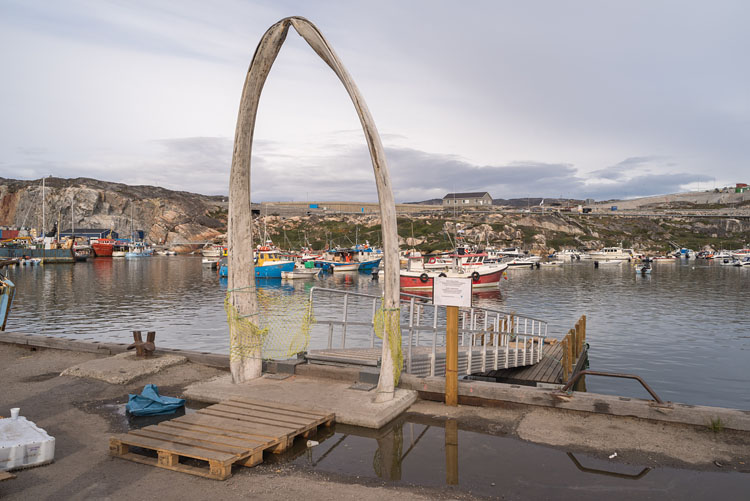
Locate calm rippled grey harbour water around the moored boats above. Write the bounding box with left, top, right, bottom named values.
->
left=0, top=256, right=750, bottom=409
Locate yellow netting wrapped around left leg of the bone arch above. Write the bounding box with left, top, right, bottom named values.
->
left=224, top=287, right=314, bottom=361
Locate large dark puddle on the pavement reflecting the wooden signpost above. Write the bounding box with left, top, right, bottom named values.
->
left=274, top=417, right=750, bottom=500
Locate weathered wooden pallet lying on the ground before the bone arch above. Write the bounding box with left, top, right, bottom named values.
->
left=109, top=398, right=335, bottom=480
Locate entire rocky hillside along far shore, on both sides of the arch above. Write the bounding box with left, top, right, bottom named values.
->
left=0, top=178, right=750, bottom=254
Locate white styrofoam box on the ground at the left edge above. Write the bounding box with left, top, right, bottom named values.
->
left=0, top=416, right=55, bottom=471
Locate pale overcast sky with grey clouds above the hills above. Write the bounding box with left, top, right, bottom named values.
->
left=0, top=0, right=750, bottom=201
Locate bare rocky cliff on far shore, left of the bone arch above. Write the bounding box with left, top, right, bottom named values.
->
left=0, top=177, right=226, bottom=245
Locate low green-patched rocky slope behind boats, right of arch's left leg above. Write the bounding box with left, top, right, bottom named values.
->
left=256, top=213, right=750, bottom=254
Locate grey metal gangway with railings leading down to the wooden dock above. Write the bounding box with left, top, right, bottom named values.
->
left=306, top=287, right=547, bottom=376
